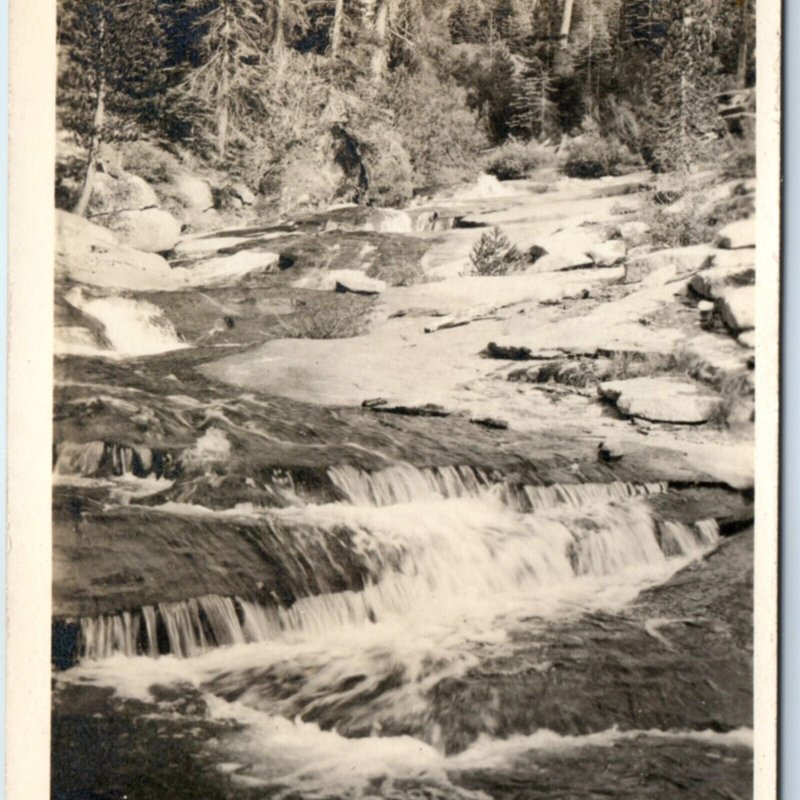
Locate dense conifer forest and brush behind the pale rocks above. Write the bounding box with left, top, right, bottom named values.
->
left=56, top=0, right=755, bottom=213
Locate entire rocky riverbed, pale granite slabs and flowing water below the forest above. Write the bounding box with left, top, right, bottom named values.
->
left=53, top=166, right=757, bottom=798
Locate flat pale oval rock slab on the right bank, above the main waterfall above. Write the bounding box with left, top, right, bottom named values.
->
left=597, top=376, right=719, bottom=425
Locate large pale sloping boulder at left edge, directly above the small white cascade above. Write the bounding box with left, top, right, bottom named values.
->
left=56, top=211, right=173, bottom=289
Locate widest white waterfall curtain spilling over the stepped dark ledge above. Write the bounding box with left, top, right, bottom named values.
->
left=73, top=465, right=719, bottom=659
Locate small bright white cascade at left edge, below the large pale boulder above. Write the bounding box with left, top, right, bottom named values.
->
left=65, top=288, right=186, bottom=356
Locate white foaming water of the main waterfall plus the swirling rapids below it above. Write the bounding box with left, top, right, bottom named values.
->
left=61, top=464, right=732, bottom=796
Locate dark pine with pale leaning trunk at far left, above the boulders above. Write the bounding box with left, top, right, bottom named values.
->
left=58, top=0, right=164, bottom=215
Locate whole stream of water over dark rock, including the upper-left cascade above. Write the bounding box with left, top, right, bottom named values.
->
left=53, top=179, right=752, bottom=800
